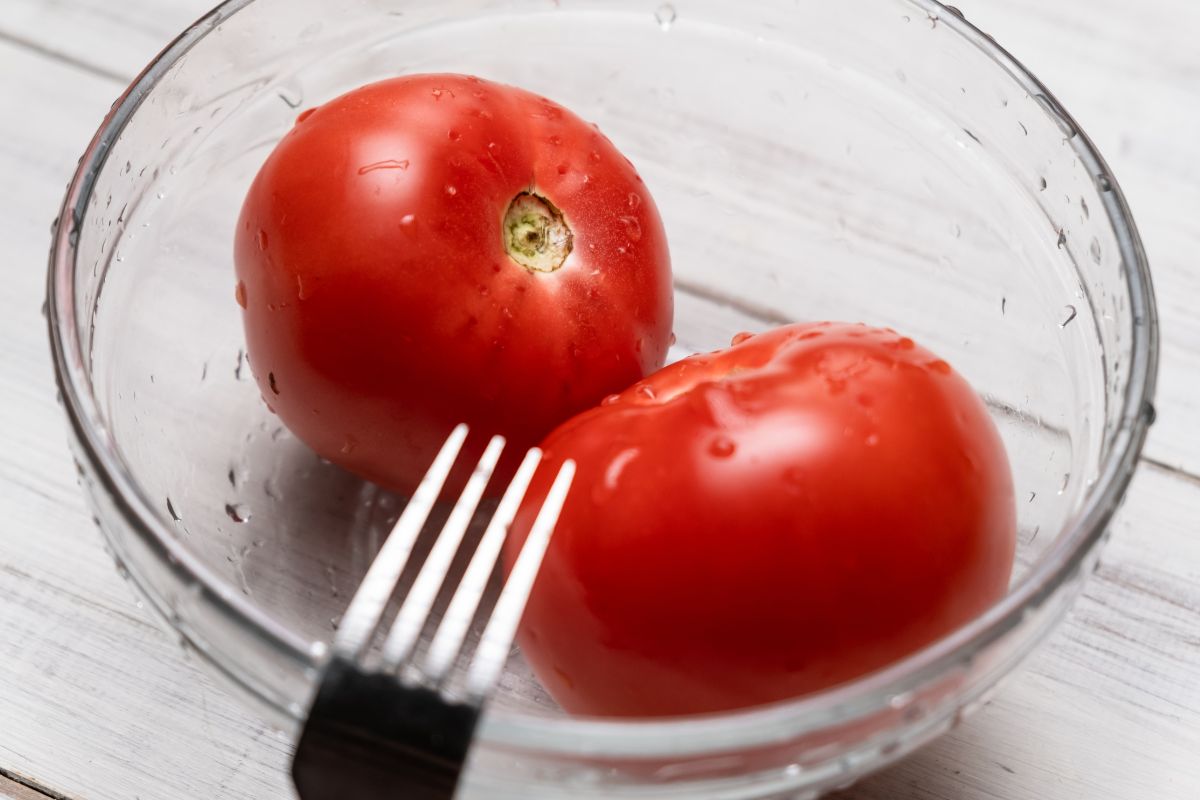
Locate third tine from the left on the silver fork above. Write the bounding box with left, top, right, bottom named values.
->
left=421, top=447, right=541, bottom=684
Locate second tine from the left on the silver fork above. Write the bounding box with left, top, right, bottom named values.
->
left=382, top=437, right=504, bottom=672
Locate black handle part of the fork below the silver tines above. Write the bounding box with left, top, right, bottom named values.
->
left=292, top=656, right=480, bottom=800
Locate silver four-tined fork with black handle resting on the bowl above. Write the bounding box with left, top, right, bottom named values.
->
left=292, top=425, right=575, bottom=800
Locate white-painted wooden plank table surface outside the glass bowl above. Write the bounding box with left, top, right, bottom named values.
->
left=0, top=0, right=1200, bottom=800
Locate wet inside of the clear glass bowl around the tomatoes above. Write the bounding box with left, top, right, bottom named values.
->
left=58, top=0, right=1133, bottom=791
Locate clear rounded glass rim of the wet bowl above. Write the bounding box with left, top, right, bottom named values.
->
left=47, top=0, right=1158, bottom=759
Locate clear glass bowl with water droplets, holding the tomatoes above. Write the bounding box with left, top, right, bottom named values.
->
left=49, top=0, right=1157, bottom=800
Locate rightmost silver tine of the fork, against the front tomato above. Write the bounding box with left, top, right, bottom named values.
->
left=467, top=461, right=575, bottom=700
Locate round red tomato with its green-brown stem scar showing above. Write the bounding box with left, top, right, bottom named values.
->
left=235, top=74, right=672, bottom=489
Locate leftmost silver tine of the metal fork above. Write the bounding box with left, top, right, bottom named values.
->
left=334, top=425, right=467, bottom=660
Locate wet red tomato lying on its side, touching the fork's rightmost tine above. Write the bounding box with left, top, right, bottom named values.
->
left=506, top=324, right=1015, bottom=716
